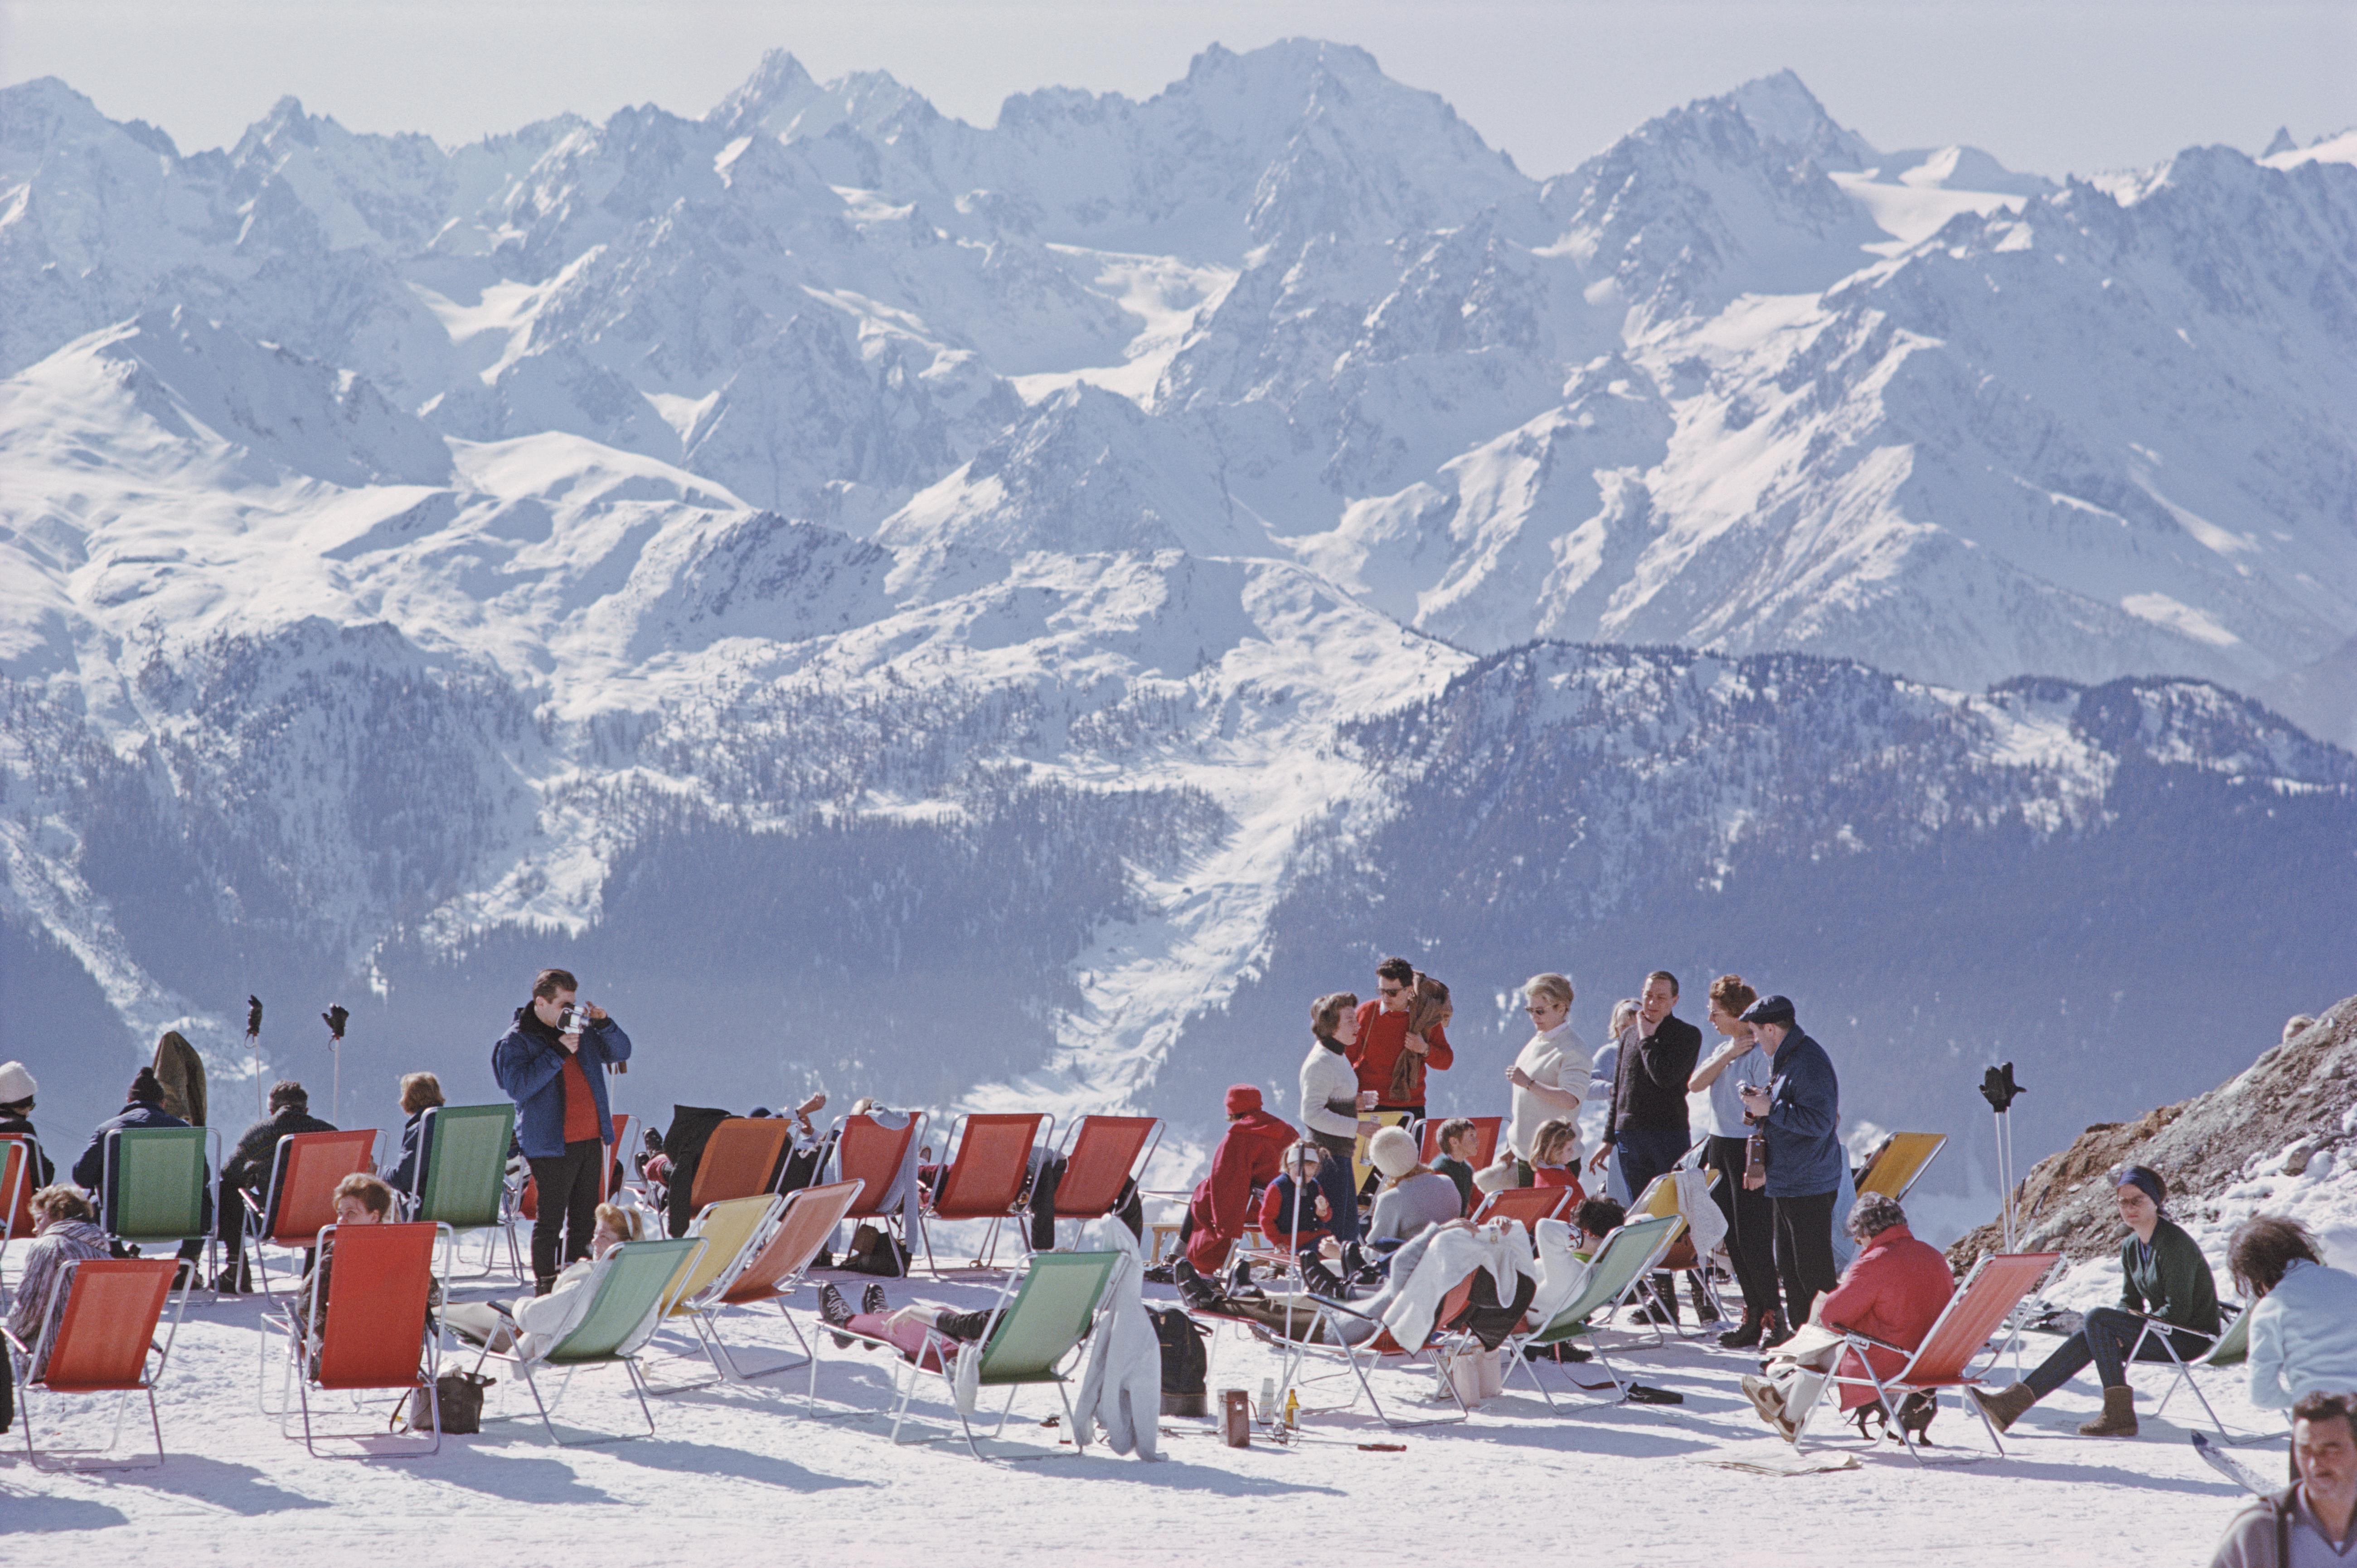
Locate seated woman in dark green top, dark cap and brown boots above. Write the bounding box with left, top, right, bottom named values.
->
left=1966, top=1165, right=2218, bottom=1438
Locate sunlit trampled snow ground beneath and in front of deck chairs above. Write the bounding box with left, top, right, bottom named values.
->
left=0, top=1167, right=2357, bottom=1566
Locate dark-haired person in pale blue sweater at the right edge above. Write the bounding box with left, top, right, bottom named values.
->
left=2227, top=1214, right=2357, bottom=1410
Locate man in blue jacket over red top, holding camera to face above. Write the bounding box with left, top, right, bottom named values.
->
left=490, top=969, right=629, bottom=1297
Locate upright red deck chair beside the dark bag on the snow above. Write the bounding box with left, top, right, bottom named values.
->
left=278, top=1221, right=448, bottom=1457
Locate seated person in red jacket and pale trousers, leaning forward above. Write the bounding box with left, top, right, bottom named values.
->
left=1744, top=1193, right=1956, bottom=1443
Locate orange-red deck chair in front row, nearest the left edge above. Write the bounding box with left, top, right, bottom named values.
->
left=0, top=1257, right=189, bottom=1469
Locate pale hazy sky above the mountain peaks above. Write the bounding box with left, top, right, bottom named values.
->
left=0, top=0, right=2357, bottom=175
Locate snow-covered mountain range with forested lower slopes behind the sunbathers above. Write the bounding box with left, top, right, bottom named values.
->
left=0, top=43, right=2357, bottom=1174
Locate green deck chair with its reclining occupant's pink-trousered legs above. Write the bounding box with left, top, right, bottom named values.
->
left=853, top=1252, right=1127, bottom=1460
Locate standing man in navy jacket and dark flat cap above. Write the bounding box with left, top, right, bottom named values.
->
left=1742, top=997, right=1843, bottom=1337
